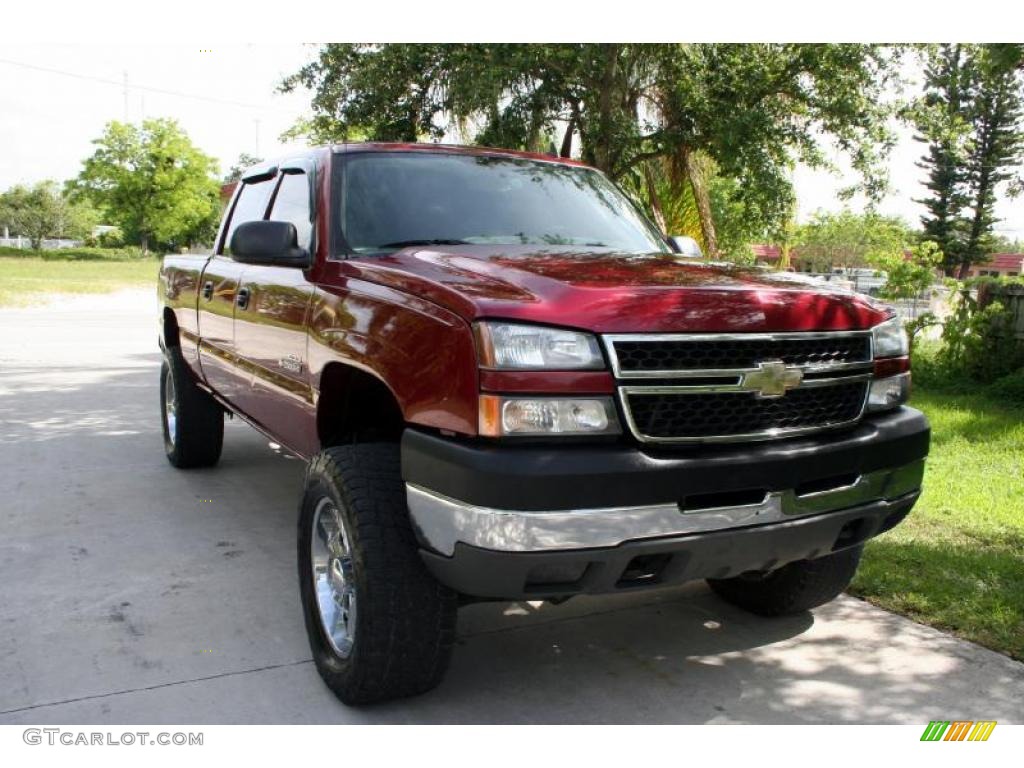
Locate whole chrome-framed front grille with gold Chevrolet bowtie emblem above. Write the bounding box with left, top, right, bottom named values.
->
left=604, top=331, right=872, bottom=442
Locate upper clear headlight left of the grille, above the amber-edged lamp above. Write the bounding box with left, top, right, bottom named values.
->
left=476, top=323, right=604, bottom=371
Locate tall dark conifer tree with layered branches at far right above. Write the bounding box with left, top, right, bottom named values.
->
left=909, top=44, right=1024, bottom=279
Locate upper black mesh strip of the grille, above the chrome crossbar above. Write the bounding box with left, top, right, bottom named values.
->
left=614, top=336, right=871, bottom=372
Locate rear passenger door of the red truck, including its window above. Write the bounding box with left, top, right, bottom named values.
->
left=199, top=175, right=276, bottom=412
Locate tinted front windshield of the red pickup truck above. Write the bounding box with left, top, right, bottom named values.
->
left=336, top=152, right=669, bottom=253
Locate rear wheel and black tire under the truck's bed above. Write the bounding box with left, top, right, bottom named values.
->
left=160, top=347, right=224, bottom=469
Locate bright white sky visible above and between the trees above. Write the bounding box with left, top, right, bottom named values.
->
left=0, top=42, right=1024, bottom=238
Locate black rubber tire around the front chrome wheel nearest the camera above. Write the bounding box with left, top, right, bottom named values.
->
left=298, top=442, right=458, bottom=705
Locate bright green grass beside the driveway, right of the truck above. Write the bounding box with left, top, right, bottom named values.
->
left=850, top=389, right=1024, bottom=660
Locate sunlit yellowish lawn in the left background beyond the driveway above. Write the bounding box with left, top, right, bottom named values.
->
left=0, top=256, right=160, bottom=306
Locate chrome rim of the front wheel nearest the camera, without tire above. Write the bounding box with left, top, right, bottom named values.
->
left=309, top=497, right=356, bottom=658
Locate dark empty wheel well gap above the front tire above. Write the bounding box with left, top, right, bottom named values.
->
left=316, top=362, right=406, bottom=447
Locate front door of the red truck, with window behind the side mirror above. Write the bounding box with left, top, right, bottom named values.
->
left=234, top=164, right=315, bottom=451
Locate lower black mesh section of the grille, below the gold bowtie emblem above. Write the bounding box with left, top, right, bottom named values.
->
left=626, top=381, right=868, bottom=440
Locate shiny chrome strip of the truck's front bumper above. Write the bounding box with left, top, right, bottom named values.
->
left=406, top=460, right=925, bottom=556
